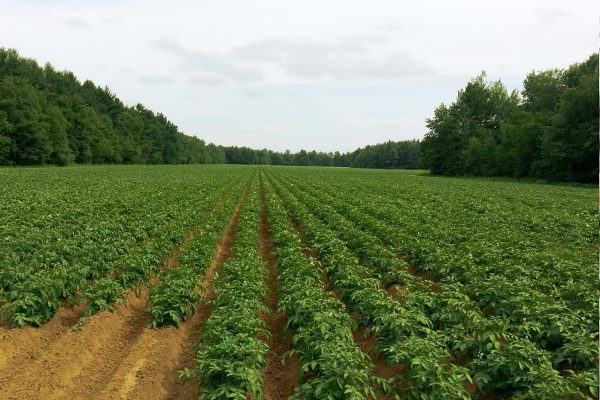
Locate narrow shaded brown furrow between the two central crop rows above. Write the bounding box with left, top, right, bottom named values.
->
left=260, top=182, right=299, bottom=400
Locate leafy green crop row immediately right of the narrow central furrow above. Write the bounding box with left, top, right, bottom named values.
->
left=265, top=175, right=389, bottom=399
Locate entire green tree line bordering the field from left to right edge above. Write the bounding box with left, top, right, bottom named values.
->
left=0, top=48, right=599, bottom=182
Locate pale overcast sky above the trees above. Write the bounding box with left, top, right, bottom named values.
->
left=0, top=0, right=599, bottom=151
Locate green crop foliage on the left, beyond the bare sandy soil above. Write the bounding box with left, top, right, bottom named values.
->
left=0, top=167, right=246, bottom=326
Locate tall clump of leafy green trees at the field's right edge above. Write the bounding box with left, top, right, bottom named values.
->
left=421, top=53, right=599, bottom=182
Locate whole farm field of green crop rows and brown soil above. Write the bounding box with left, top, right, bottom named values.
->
left=0, top=165, right=599, bottom=400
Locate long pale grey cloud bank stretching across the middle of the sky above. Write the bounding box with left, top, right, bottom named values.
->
left=153, top=34, right=435, bottom=84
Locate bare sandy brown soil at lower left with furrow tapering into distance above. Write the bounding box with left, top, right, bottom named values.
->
left=0, top=191, right=247, bottom=400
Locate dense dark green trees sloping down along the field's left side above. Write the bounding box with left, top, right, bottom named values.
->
left=0, top=48, right=226, bottom=165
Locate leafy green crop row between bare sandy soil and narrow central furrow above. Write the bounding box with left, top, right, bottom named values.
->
left=186, top=179, right=269, bottom=400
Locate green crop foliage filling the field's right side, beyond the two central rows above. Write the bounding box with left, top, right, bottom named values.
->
left=268, top=169, right=598, bottom=399
